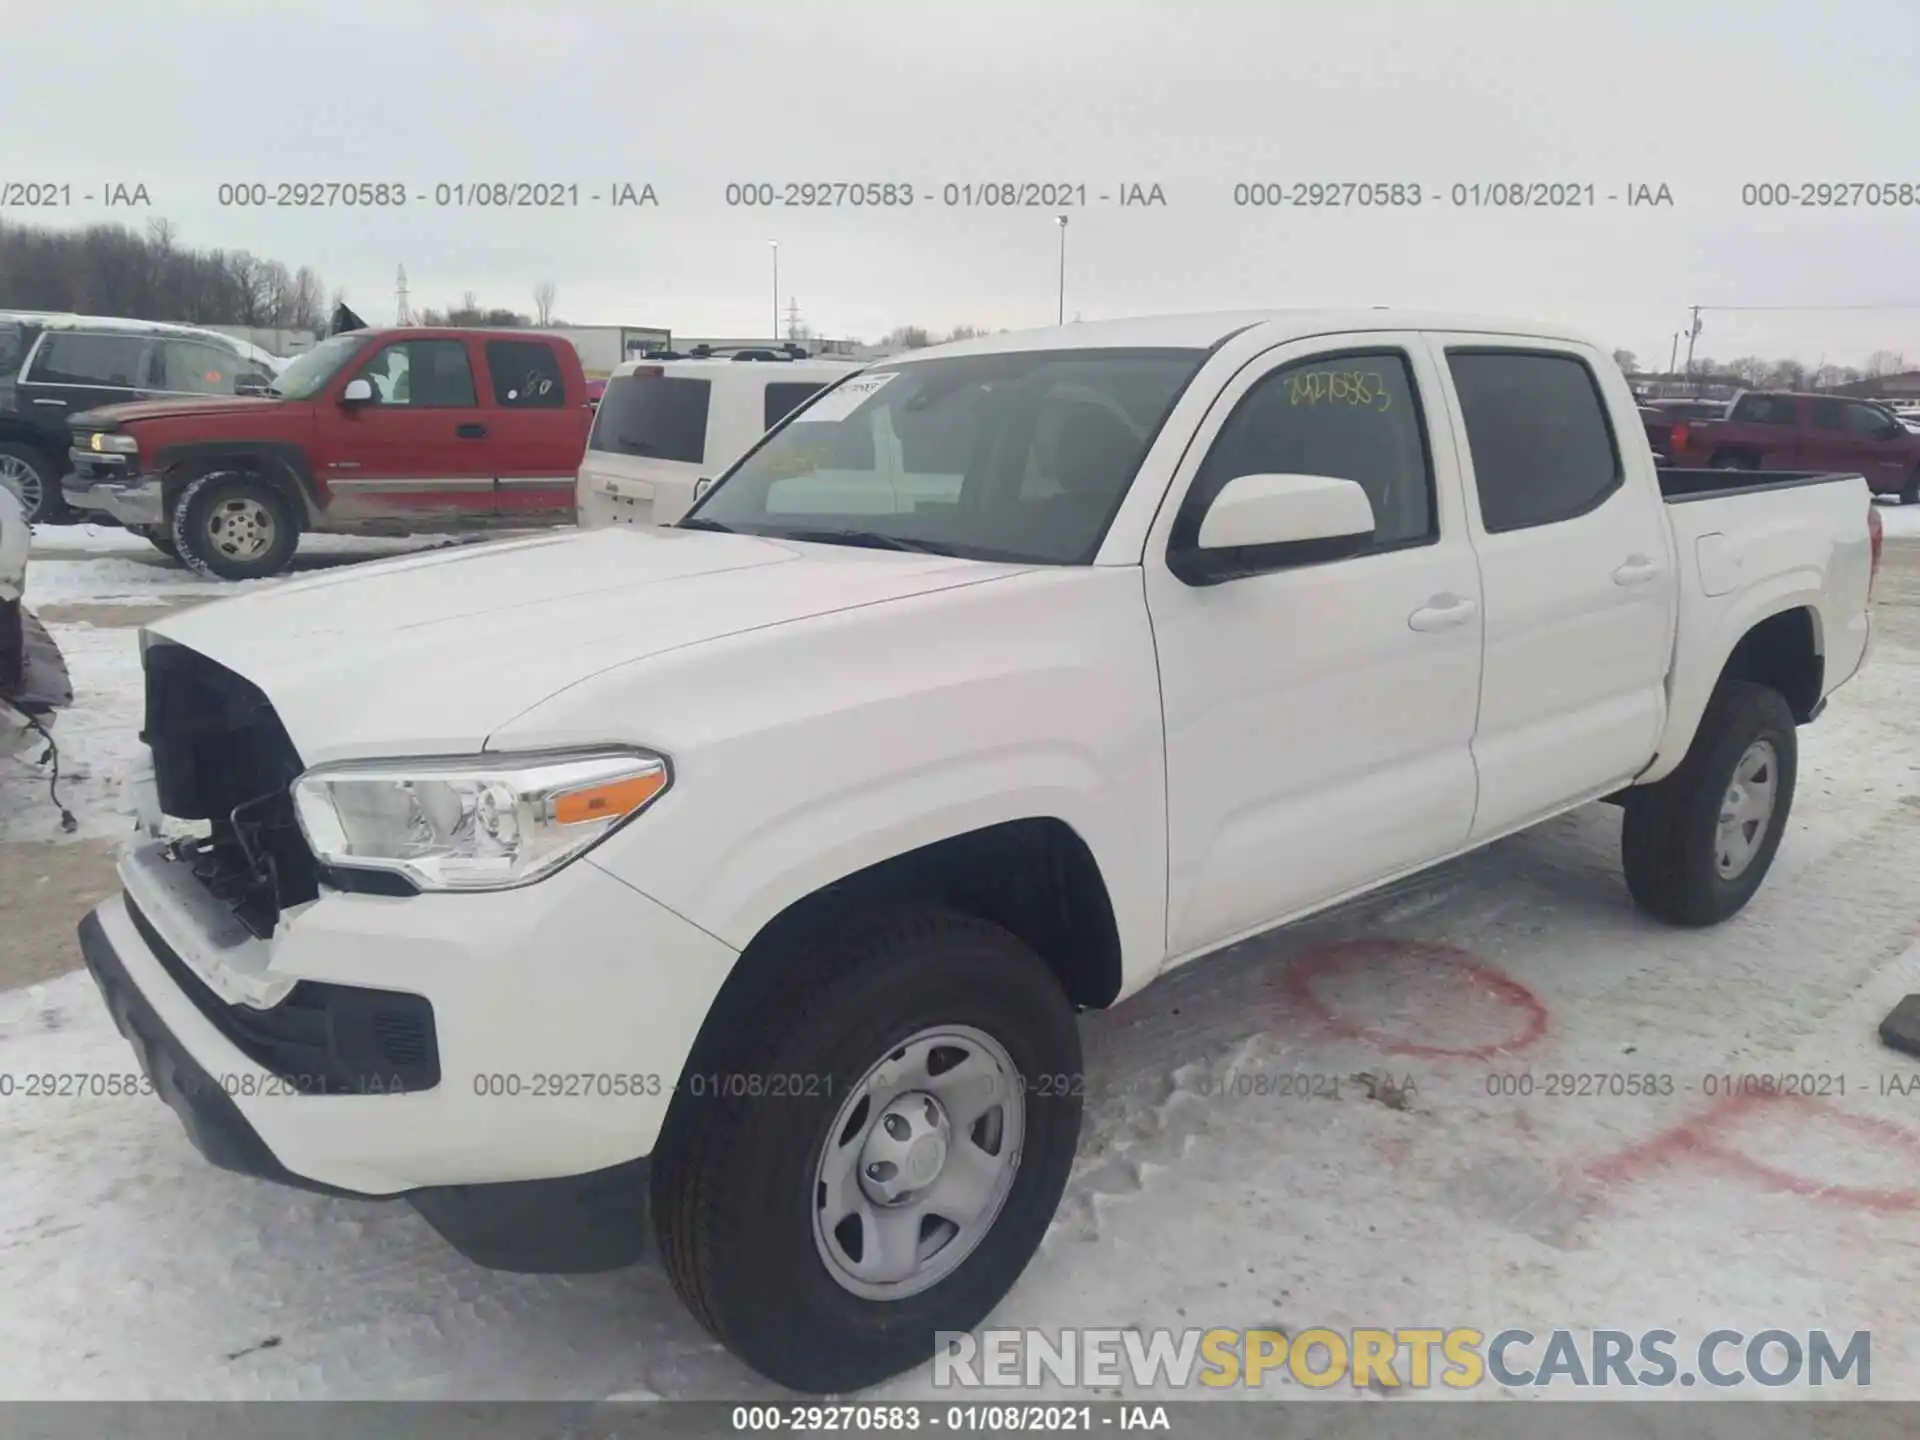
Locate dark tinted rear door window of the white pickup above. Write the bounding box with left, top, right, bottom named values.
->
left=1448, top=349, right=1622, bottom=532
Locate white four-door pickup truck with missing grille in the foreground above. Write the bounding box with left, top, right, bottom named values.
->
left=81, top=311, right=1880, bottom=1390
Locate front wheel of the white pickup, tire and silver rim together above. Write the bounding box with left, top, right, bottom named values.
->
left=653, top=910, right=1081, bottom=1392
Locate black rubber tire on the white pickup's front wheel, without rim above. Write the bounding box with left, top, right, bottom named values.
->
left=651, top=910, right=1081, bottom=1394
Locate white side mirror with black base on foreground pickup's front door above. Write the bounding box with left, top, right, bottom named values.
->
left=1167, top=474, right=1375, bottom=586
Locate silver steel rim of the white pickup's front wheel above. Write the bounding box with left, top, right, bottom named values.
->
left=814, top=1025, right=1025, bottom=1300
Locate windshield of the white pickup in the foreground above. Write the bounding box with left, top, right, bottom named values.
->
left=682, top=349, right=1206, bottom=564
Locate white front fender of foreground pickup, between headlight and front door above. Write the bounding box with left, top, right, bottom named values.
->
left=488, top=566, right=1167, bottom=989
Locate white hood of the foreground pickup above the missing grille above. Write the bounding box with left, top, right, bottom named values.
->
left=142, top=528, right=1029, bottom=764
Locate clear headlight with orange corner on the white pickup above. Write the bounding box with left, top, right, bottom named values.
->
left=292, top=749, right=672, bottom=891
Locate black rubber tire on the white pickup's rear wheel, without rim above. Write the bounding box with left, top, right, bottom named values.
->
left=1620, top=680, right=1799, bottom=925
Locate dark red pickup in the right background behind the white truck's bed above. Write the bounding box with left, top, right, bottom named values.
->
left=1667, top=390, right=1920, bottom=505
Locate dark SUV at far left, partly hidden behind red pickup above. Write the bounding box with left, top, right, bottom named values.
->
left=0, top=311, right=273, bottom=522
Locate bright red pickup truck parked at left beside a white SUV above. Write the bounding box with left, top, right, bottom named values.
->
left=63, top=328, right=593, bottom=580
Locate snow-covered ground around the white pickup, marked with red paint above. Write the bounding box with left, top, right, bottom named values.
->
left=0, top=507, right=1920, bottom=1400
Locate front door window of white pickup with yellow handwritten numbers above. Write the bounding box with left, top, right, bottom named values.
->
left=1173, top=351, right=1440, bottom=551
